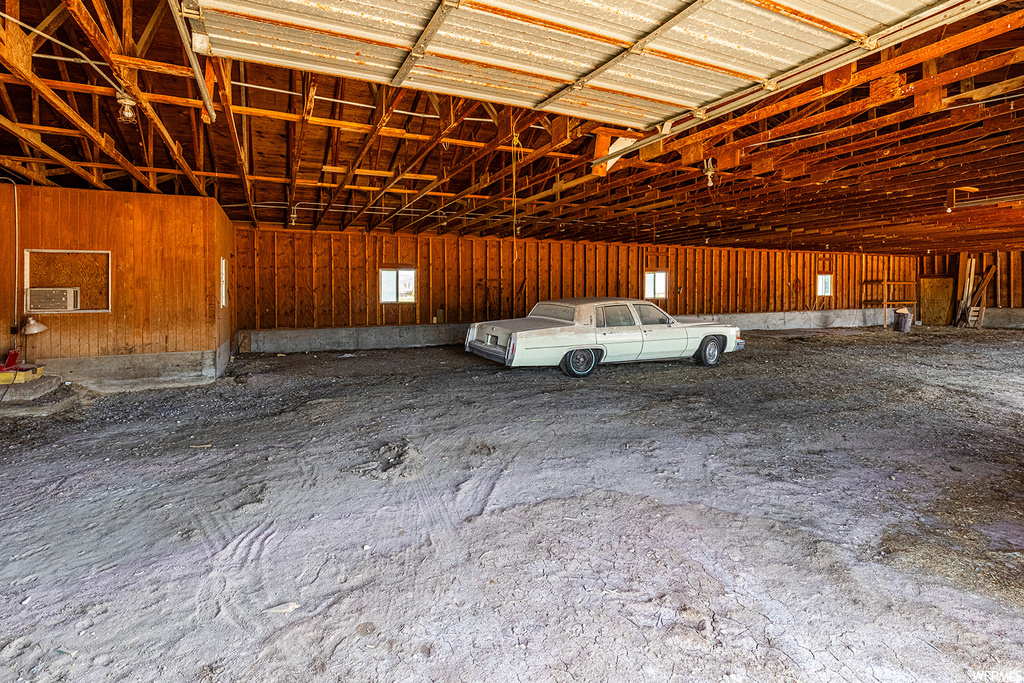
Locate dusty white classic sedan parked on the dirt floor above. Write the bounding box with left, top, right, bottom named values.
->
left=466, top=298, right=743, bottom=377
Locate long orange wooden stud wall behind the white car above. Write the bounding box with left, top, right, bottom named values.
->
left=234, top=225, right=918, bottom=330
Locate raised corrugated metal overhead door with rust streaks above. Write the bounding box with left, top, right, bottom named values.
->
left=200, top=0, right=954, bottom=126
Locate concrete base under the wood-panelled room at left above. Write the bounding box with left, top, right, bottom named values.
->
left=44, top=350, right=222, bottom=393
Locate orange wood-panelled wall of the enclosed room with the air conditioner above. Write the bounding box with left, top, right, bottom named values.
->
left=0, top=184, right=233, bottom=360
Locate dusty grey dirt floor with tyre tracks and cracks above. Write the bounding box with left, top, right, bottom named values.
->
left=0, top=328, right=1024, bottom=683
